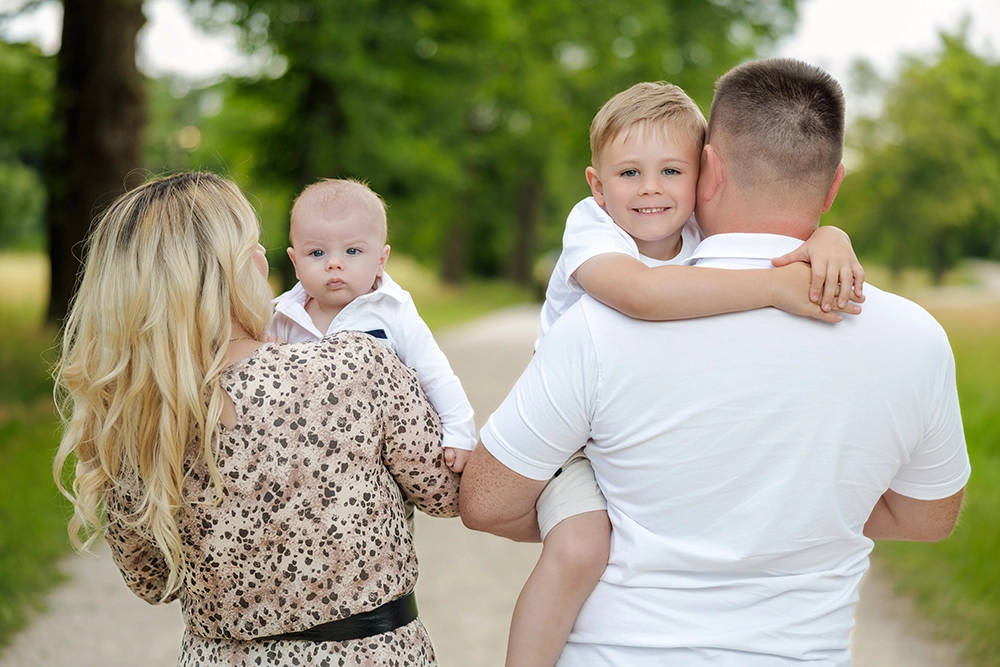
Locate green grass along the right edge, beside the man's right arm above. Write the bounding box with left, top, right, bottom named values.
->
left=875, top=306, right=1000, bottom=667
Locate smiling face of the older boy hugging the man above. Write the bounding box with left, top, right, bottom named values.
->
left=587, top=126, right=701, bottom=259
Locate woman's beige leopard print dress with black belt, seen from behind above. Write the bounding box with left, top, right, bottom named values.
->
left=105, top=333, right=458, bottom=667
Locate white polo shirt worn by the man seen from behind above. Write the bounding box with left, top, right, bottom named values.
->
left=480, top=234, right=969, bottom=667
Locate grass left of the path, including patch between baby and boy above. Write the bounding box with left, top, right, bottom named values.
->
left=0, top=252, right=530, bottom=653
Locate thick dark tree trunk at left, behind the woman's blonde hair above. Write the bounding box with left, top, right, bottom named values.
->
left=46, top=0, right=146, bottom=322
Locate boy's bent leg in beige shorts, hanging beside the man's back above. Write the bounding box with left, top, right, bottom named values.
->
left=506, top=453, right=611, bottom=667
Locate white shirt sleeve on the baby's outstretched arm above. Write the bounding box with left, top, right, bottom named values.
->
left=396, top=297, right=477, bottom=450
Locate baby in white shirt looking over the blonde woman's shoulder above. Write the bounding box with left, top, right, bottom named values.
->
left=267, top=180, right=476, bottom=472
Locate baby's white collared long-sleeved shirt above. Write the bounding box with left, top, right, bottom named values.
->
left=267, top=273, right=478, bottom=450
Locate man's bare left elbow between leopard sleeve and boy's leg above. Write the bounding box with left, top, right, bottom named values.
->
left=459, top=441, right=546, bottom=542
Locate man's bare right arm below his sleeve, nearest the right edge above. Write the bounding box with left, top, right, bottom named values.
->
left=864, top=488, right=965, bottom=542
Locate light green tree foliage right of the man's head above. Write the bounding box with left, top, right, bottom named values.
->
left=831, top=24, right=1000, bottom=280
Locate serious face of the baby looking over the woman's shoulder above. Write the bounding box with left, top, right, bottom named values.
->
left=288, top=202, right=389, bottom=314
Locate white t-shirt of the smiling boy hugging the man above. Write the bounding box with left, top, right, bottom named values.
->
left=540, top=197, right=702, bottom=336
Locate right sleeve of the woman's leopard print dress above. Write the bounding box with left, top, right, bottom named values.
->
left=382, top=354, right=459, bottom=517
